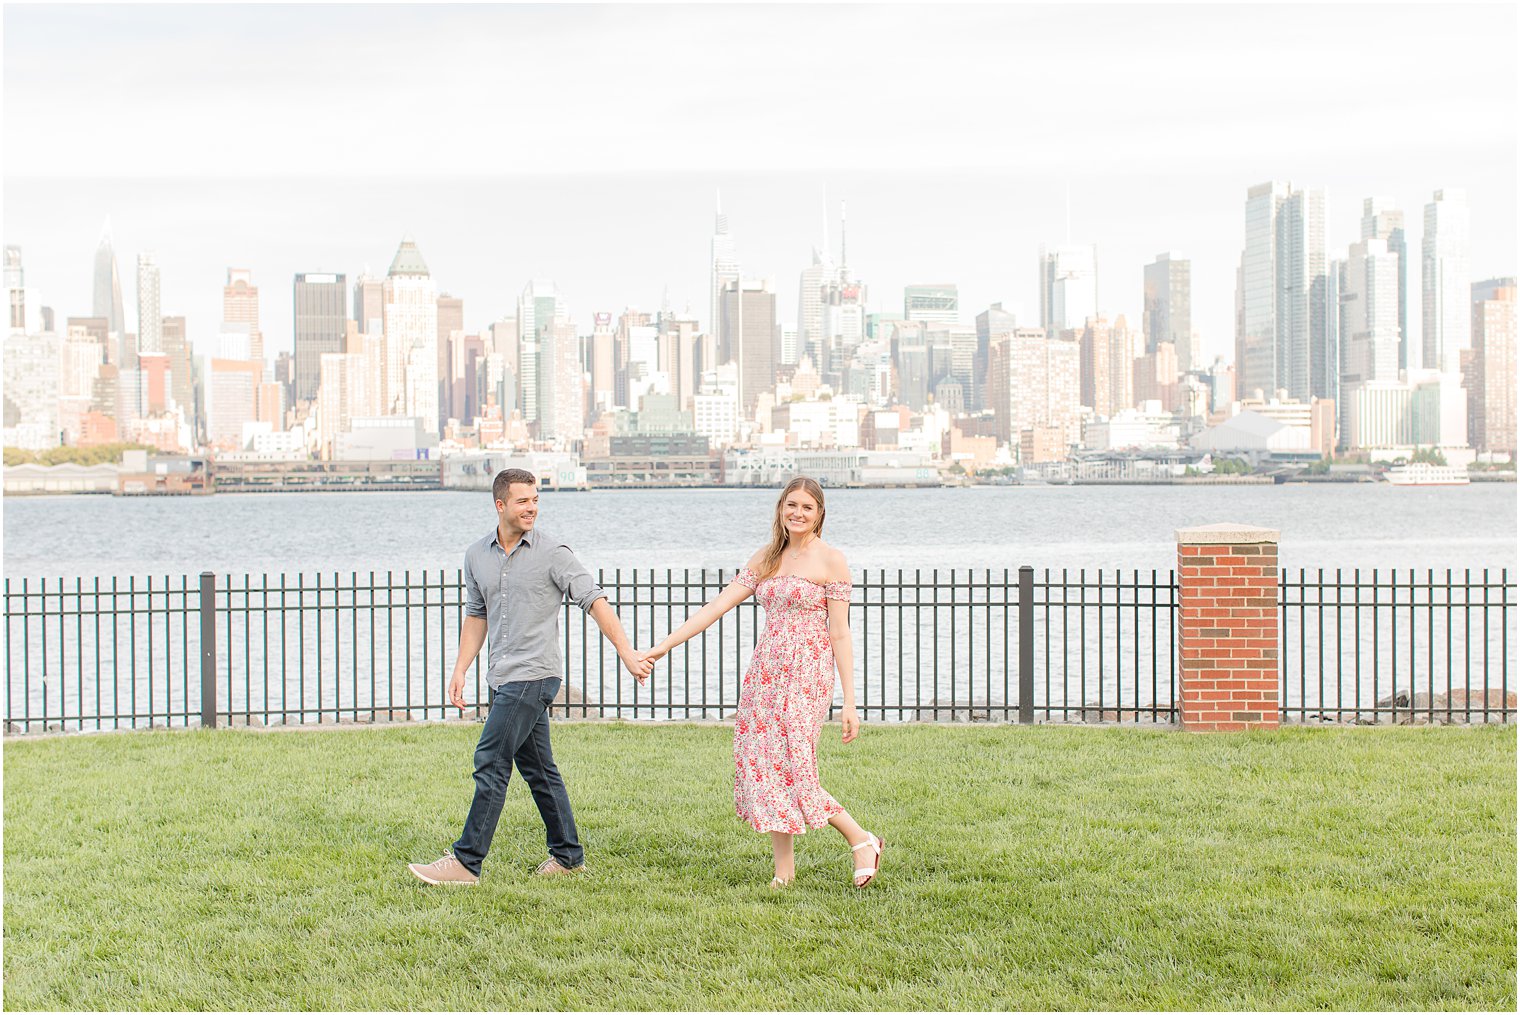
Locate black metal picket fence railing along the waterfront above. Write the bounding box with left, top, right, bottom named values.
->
left=5, top=567, right=1515, bottom=732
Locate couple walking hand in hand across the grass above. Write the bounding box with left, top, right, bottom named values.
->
left=409, top=470, right=886, bottom=889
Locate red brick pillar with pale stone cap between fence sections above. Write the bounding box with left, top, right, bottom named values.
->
left=1176, top=524, right=1280, bottom=732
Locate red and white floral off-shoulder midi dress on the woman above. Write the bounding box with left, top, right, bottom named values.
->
left=734, top=568, right=851, bottom=834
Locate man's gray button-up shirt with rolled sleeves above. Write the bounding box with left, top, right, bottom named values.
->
left=465, top=526, right=606, bottom=688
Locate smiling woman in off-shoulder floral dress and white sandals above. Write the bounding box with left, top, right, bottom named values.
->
left=651, top=476, right=886, bottom=889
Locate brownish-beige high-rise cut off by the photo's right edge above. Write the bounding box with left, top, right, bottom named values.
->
left=1464, top=278, right=1515, bottom=457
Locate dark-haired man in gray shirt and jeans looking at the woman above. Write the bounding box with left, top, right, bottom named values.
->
left=407, top=470, right=654, bottom=884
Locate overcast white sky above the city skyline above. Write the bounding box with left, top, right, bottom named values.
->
left=3, top=3, right=1520, bottom=364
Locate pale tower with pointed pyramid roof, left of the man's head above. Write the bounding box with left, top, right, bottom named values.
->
left=383, top=236, right=439, bottom=435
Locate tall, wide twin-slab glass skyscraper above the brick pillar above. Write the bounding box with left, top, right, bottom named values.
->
left=1236, top=182, right=1339, bottom=400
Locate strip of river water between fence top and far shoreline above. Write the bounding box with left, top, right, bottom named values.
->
left=5, top=483, right=1515, bottom=579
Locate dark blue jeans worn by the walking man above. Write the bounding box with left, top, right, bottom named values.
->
left=454, top=676, right=585, bottom=877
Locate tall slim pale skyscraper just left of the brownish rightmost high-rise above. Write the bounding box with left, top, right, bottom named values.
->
left=1420, top=187, right=1473, bottom=374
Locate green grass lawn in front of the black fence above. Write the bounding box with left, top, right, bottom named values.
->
left=5, top=723, right=1515, bottom=1010
